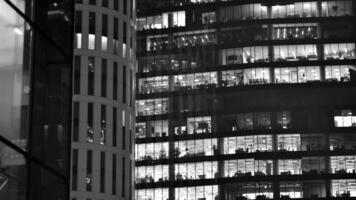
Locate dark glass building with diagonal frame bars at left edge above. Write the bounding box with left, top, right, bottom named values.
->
left=0, top=0, right=74, bottom=200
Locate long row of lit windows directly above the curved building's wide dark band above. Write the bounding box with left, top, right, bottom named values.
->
left=138, top=65, right=354, bottom=94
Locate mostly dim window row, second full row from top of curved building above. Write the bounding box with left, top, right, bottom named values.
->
left=139, top=22, right=354, bottom=51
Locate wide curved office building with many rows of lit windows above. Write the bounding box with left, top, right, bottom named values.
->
left=135, top=0, right=356, bottom=200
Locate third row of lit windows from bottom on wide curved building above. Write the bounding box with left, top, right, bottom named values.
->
left=136, top=134, right=356, bottom=160
